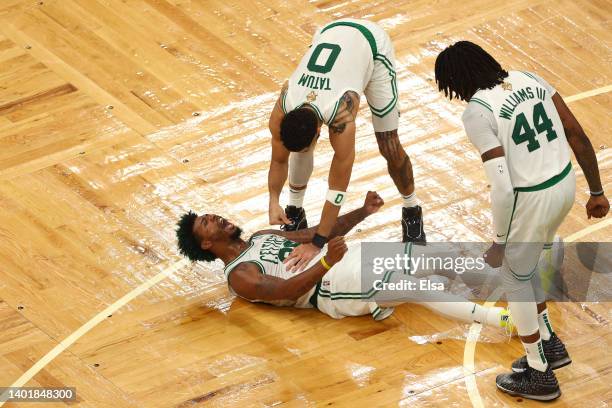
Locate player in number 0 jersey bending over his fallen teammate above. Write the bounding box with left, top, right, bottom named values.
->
left=268, top=19, right=425, bottom=270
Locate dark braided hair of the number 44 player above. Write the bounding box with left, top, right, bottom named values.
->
left=435, top=41, right=508, bottom=101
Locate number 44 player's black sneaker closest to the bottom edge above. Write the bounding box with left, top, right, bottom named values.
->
left=495, top=366, right=561, bottom=401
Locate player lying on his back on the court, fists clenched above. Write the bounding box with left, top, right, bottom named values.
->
left=177, top=191, right=510, bottom=328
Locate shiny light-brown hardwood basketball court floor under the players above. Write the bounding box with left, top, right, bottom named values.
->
left=0, top=0, right=612, bottom=408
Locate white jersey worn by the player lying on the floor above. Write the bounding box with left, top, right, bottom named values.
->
left=223, top=234, right=327, bottom=308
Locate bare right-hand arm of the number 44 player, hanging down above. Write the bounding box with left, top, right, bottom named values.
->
left=553, top=93, right=610, bottom=218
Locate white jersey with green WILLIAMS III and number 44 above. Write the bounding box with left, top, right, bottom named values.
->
left=470, top=71, right=570, bottom=188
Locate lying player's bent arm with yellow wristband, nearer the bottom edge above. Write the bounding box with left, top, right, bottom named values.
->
left=228, top=237, right=347, bottom=302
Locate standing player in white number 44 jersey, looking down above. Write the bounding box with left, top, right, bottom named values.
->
left=435, top=41, right=610, bottom=400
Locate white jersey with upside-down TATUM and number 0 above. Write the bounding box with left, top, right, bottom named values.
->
left=282, top=19, right=379, bottom=125
